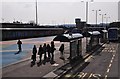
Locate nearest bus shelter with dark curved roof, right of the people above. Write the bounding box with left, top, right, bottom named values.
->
left=53, top=33, right=83, bottom=60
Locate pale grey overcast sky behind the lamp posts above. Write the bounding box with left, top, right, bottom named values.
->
left=0, top=0, right=119, bottom=25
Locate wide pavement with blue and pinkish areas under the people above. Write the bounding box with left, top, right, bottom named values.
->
left=0, top=36, right=85, bottom=78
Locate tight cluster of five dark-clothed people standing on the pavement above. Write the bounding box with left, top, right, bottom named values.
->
left=31, top=41, right=56, bottom=63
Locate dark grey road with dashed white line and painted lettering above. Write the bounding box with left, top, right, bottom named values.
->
left=64, top=43, right=120, bottom=79
